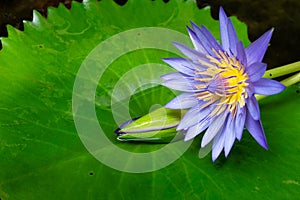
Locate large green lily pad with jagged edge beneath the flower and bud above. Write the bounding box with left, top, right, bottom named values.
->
left=0, top=0, right=300, bottom=200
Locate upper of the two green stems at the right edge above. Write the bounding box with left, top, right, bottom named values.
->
left=263, top=61, right=300, bottom=78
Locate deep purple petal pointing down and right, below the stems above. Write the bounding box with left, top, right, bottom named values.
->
left=246, top=114, right=268, bottom=149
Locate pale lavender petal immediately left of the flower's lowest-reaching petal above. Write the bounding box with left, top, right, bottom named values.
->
left=201, top=112, right=227, bottom=147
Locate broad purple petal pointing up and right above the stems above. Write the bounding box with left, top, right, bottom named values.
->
left=246, top=29, right=274, bottom=66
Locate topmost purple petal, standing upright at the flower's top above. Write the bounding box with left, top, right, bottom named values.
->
left=219, top=7, right=229, bottom=52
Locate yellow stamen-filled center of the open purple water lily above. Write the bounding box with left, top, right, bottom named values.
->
left=195, top=49, right=249, bottom=115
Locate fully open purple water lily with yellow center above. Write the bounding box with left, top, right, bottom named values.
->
left=162, top=8, right=285, bottom=161
